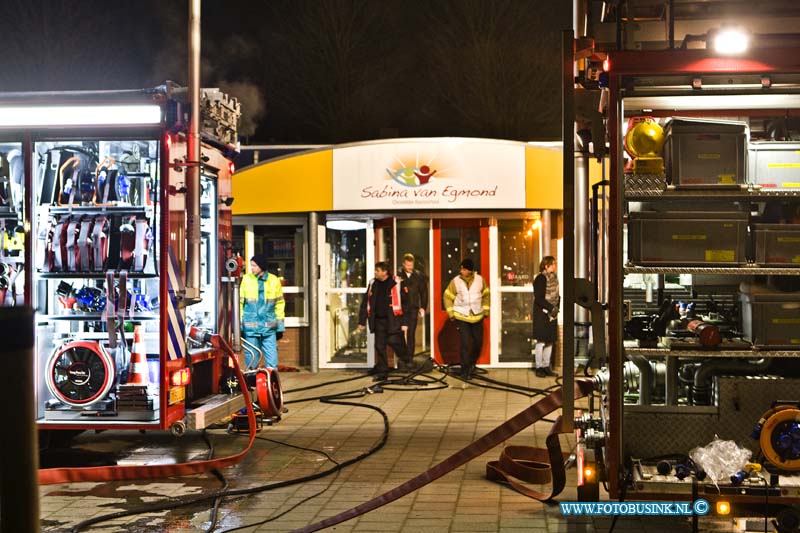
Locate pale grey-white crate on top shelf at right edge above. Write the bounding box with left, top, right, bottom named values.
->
left=748, top=141, right=800, bottom=191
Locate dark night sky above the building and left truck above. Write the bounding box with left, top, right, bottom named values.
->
left=0, top=0, right=572, bottom=143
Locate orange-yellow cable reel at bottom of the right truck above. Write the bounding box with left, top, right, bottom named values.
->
left=758, top=407, right=800, bottom=471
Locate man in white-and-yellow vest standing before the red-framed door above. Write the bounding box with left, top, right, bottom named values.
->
left=444, top=257, right=490, bottom=379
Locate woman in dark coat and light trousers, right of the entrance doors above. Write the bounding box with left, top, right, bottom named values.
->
left=533, top=255, right=561, bottom=378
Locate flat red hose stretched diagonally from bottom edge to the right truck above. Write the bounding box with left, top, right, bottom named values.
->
left=292, top=379, right=593, bottom=533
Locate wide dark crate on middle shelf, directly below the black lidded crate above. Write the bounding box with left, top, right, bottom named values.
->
left=628, top=211, right=748, bottom=266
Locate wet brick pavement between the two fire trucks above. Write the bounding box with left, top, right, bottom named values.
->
left=40, top=369, right=735, bottom=533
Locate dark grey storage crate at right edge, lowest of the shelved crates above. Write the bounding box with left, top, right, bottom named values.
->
left=739, top=283, right=800, bottom=350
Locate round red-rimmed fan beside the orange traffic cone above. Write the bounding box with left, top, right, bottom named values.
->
left=45, top=341, right=116, bottom=407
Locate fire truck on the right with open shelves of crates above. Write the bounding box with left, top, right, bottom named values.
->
left=564, top=3, right=800, bottom=531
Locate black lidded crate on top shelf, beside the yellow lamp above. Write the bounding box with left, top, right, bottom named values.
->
left=664, top=118, right=748, bottom=188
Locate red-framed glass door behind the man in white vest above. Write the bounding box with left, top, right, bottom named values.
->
left=431, top=219, right=491, bottom=364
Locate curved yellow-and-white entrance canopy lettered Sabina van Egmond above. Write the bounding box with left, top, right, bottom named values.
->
left=233, top=137, right=600, bottom=215
